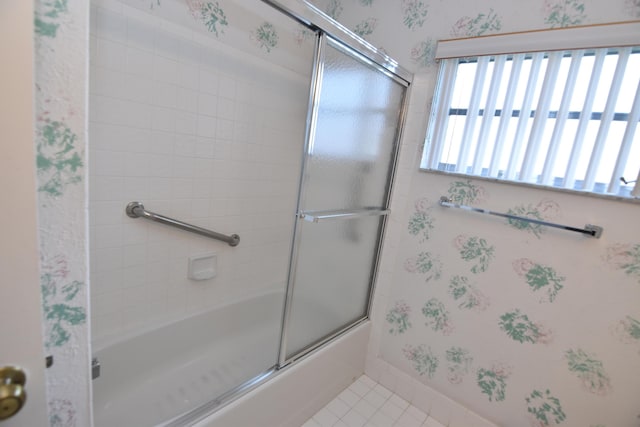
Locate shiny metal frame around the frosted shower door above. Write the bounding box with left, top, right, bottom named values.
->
left=278, top=32, right=411, bottom=369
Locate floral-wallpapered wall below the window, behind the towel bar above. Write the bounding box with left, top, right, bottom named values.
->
left=378, top=173, right=640, bottom=427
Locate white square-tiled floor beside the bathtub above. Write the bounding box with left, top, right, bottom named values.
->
left=302, top=375, right=444, bottom=427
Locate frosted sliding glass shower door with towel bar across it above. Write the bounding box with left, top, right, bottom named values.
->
left=280, top=35, right=407, bottom=364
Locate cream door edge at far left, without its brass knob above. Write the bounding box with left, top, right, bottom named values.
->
left=0, top=0, right=48, bottom=427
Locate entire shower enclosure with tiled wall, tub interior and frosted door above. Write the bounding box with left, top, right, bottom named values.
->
left=89, top=0, right=411, bottom=427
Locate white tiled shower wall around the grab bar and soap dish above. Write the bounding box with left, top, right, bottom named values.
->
left=89, top=1, right=313, bottom=348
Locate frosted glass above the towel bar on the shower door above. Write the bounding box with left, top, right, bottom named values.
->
left=304, top=39, right=404, bottom=211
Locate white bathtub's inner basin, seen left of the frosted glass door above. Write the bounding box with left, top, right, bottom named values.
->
left=93, top=293, right=284, bottom=427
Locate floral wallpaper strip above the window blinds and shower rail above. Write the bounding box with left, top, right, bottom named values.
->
left=307, top=0, right=640, bottom=72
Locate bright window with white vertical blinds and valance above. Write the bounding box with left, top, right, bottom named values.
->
left=421, top=23, right=640, bottom=197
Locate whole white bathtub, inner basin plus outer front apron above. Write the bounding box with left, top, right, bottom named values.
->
left=93, top=292, right=369, bottom=427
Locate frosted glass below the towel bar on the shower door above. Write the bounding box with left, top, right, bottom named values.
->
left=287, top=216, right=384, bottom=357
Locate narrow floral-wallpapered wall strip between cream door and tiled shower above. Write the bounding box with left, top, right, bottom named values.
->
left=34, top=0, right=91, bottom=427
